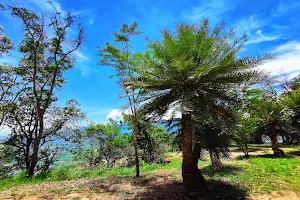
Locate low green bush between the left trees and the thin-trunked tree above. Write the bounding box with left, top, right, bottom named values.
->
left=76, top=119, right=133, bottom=168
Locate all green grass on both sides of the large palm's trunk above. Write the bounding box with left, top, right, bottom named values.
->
left=0, top=146, right=300, bottom=194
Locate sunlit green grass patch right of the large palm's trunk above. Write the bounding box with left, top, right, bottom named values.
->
left=202, top=146, right=300, bottom=194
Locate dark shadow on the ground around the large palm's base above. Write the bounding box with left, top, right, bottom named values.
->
left=133, top=180, right=248, bottom=200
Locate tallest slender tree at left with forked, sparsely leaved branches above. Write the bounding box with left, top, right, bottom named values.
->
left=2, top=2, right=84, bottom=176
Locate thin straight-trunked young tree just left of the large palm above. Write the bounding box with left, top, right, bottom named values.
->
left=98, top=23, right=141, bottom=177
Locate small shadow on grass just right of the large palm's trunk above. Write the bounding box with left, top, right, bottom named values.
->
left=201, top=165, right=242, bottom=177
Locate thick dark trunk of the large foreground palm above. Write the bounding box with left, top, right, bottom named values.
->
left=182, top=113, right=206, bottom=192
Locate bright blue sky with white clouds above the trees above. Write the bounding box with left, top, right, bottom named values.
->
left=0, top=0, right=300, bottom=126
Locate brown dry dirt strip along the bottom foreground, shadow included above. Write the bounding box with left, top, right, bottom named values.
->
left=0, top=171, right=300, bottom=200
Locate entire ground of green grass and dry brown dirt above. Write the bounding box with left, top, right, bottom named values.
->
left=0, top=145, right=300, bottom=199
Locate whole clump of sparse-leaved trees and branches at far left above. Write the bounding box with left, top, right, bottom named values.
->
left=0, top=1, right=84, bottom=176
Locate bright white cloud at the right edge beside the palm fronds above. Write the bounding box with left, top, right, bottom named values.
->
left=259, top=41, right=300, bottom=79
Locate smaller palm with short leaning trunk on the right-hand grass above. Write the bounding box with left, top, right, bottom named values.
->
left=241, top=84, right=287, bottom=156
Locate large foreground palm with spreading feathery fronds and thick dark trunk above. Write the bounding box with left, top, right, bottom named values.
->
left=131, top=19, right=272, bottom=189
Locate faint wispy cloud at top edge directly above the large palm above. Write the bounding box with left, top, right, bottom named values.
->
left=182, top=0, right=233, bottom=23
